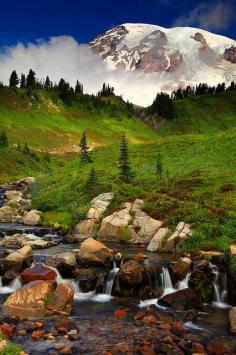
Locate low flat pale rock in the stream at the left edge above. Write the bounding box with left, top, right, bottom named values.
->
left=0, top=234, right=57, bottom=249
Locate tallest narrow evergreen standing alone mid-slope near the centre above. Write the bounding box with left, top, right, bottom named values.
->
left=119, top=135, right=133, bottom=183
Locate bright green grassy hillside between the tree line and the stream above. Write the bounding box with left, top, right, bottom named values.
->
left=0, top=89, right=236, bottom=251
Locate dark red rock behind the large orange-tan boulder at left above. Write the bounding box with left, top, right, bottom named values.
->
left=20, top=264, right=57, bottom=283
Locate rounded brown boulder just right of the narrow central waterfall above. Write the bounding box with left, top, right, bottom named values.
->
left=117, top=260, right=143, bottom=285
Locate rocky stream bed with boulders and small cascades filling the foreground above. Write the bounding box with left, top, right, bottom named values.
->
left=0, top=178, right=236, bottom=355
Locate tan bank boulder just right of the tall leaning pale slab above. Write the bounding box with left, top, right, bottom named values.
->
left=98, top=208, right=132, bottom=241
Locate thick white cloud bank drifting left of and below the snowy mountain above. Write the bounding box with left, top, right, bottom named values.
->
left=0, top=36, right=158, bottom=106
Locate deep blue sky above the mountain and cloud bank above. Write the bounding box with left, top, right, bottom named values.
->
left=0, top=0, right=236, bottom=46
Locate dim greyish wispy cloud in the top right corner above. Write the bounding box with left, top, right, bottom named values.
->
left=174, top=0, right=234, bottom=30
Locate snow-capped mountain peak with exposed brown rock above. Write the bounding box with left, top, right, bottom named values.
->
left=90, top=24, right=236, bottom=91
